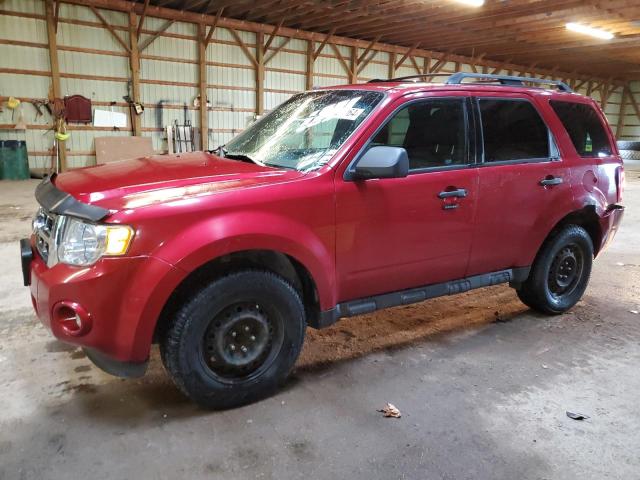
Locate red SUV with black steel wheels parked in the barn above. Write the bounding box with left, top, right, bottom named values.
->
left=21, top=73, right=624, bottom=408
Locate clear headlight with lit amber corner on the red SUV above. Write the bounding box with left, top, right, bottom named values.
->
left=58, top=217, right=133, bottom=266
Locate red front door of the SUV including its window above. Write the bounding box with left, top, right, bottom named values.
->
left=336, top=96, right=478, bottom=301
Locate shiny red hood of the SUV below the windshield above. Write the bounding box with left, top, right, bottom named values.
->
left=54, top=152, right=303, bottom=211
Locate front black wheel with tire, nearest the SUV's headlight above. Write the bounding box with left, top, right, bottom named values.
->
left=160, top=270, right=306, bottom=409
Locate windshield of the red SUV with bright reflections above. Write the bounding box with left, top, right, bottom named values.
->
left=224, top=90, right=384, bottom=172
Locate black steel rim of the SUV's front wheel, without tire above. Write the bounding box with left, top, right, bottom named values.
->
left=202, top=301, right=282, bottom=382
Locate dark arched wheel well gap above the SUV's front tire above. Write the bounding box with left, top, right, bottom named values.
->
left=153, top=250, right=320, bottom=342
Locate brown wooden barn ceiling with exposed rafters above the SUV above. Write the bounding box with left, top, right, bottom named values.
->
left=64, top=0, right=640, bottom=85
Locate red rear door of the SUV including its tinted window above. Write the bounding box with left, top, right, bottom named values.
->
left=467, top=92, right=571, bottom=275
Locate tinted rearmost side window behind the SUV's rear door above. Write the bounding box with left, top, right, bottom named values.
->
left=550, top=100, right=612, bottom=157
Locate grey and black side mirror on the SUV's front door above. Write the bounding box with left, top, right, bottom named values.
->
left=351, top=146, right=409, bottom=180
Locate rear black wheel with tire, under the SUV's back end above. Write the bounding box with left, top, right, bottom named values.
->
left=517, top=225, right=593, bottom=315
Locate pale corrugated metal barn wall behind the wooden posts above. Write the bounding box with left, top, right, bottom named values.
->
left=0, top=0, right=640, bottom=168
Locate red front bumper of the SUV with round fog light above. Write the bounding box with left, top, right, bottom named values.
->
left=21, top=238, right=176, bottom=376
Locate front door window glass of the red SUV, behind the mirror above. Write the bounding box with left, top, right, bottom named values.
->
left=371, top=98, right=467, bottom=170
